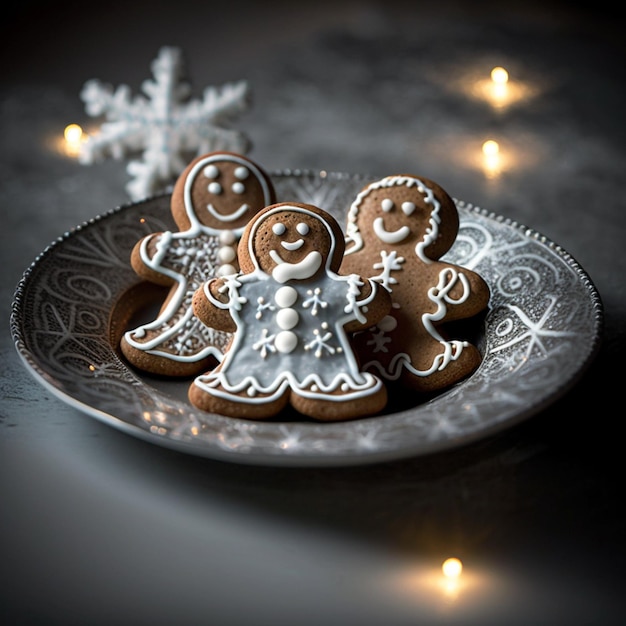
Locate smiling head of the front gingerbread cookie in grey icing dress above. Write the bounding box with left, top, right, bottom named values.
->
left=239, top=203, right=344, bottom=283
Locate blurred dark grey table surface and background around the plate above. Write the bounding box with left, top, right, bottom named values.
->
left=0, top=0, right=626, bottom=626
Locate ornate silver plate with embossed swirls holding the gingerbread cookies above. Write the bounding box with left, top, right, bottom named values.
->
left=11, top=171, right=603, bottom=466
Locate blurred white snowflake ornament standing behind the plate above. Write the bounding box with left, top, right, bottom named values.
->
left=79, top=47, right=250, bottom=200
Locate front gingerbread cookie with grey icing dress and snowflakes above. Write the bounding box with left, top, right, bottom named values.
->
left=189, top=202, right=391, bottom=421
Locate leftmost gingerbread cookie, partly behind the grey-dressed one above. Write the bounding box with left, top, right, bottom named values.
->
left=120, top=152, right=276, bottom=376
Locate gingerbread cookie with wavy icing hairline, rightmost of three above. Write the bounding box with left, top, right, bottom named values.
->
left=341, top=174, right=489, bottom=392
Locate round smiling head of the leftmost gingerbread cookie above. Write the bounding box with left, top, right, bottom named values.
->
left=172, top=152, right=275, bottom=232
